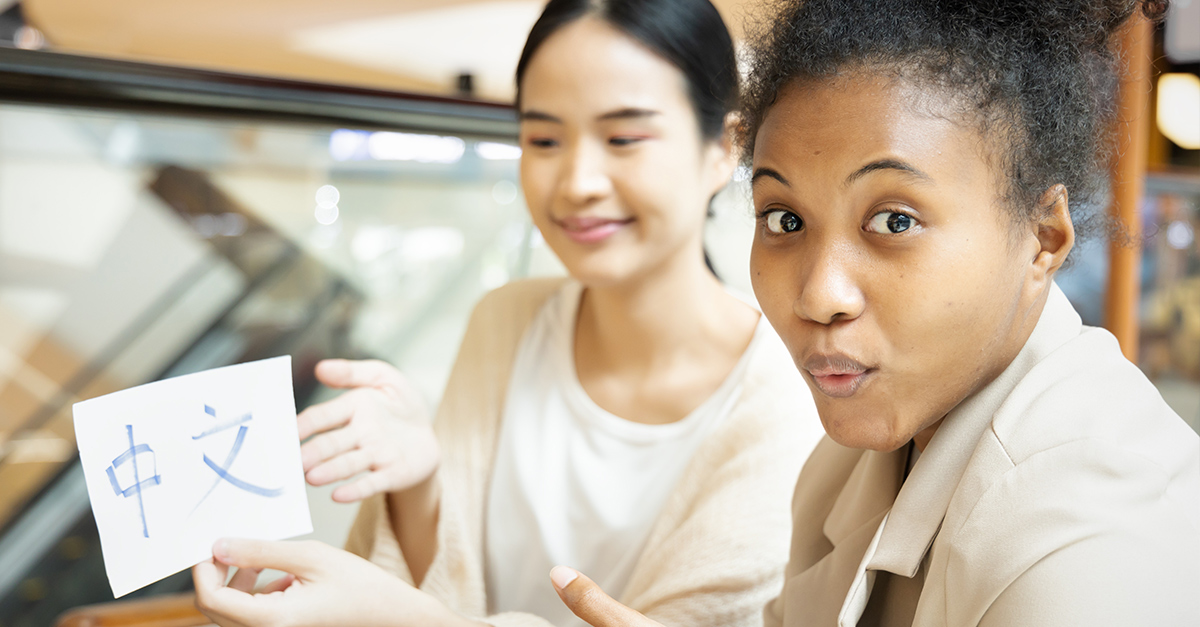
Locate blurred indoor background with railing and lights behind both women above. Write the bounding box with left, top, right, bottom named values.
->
left=0, top=0, right=1200, bottom=627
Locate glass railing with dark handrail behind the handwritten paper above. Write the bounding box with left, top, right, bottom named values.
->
left=0, top=49, right=558, bottom=627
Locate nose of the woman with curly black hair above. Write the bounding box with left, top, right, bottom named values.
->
left=792, top=243, right=866, bottom=324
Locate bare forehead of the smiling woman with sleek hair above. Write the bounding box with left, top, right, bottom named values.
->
left=521, top=18, right=690, bottom=118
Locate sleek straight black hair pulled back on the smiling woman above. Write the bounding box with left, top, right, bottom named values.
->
left=516, top=0, right=738, bottom=139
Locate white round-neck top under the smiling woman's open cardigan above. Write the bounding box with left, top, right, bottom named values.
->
left=485, top=281, right=766, bottom=626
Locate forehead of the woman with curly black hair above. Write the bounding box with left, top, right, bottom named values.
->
left=754, top=73, right=990, bottom=179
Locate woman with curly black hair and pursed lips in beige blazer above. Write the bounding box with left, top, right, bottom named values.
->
left=551, top=0, right=1200, bottom=627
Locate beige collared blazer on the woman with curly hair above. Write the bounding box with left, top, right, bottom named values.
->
left=766, top=287, right=1200, bottom=627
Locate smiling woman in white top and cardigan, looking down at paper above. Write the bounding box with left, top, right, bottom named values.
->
left=194, top=0, right=821, bottom=626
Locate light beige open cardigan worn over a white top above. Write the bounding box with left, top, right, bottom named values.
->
left=347, top=279, right=823, bottom=626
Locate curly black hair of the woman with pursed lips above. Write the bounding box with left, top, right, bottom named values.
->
left=742, top=0, right=1166, bottom=239
